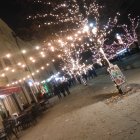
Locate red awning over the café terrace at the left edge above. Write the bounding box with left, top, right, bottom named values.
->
left=0, top=86, right=21, bottom=95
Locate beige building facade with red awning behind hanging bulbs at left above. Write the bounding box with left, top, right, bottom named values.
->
left=0, top=19, right=53, bottom=127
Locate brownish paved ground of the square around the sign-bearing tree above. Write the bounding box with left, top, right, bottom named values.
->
left=20, top=69, right=140, bottom=140
